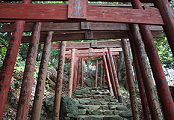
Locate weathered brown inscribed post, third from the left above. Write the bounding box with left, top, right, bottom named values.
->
left=31, top=31, right=53, bottom=120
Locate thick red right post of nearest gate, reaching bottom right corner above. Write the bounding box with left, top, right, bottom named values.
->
left=132, top=0, right=174, bottom=119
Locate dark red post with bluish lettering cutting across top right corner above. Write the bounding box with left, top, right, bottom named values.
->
left=153, top=0, right=174, bottom=56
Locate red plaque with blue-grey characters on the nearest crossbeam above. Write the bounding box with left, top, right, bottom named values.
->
left=68, top=0, right=88, bottom=19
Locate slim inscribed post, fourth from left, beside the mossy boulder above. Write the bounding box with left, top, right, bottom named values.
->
left=53, top=41, right=66, bottom=120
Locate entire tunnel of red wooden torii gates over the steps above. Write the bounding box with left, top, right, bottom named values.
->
left=0, top=0, right=174, bottom=120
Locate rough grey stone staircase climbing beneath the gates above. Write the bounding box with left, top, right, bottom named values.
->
left=73, top=88, right=133, bottom=120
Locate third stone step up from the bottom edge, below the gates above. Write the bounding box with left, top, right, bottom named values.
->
left=78, top=104, right=127, bottom=111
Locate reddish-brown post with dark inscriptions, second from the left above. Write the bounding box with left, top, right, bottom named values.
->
left=16, top=22, right=42, bottom=120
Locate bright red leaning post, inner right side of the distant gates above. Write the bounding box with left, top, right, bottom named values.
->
left=106, top=48, right=118, bottom=98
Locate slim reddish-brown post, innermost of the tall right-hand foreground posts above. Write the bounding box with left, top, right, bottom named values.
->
left=121, top=39, right=139, bottom=120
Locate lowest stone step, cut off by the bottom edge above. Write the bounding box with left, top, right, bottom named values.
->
left=77, top=115, right=132, bottom=120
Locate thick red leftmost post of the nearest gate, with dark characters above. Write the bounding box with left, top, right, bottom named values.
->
left=0, top=0, right=31, bottom=119
